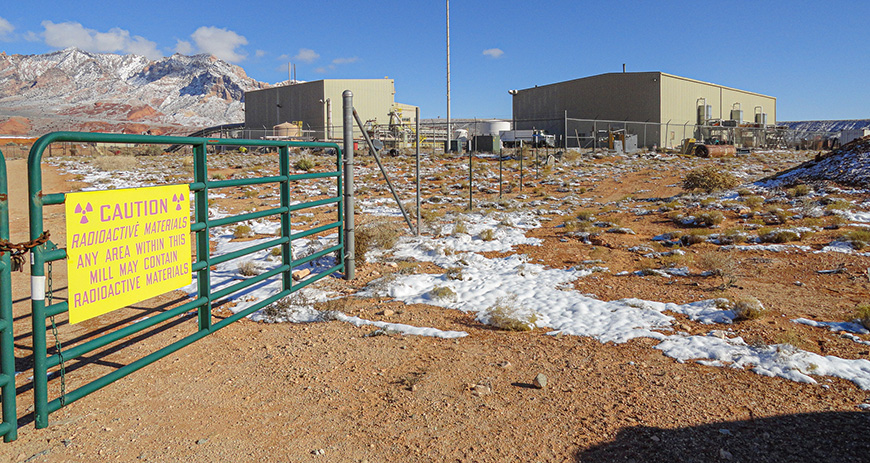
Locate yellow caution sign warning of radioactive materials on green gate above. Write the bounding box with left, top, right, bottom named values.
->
left=66, top=185, right=191, bottom=323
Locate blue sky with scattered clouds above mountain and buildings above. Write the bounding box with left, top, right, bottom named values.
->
left=0, top=0, right=870, bottom=120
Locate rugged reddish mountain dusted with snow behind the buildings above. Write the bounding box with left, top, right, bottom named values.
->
left=0, top=48, right=269, bottom=134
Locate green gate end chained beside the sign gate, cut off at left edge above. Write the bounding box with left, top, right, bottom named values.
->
left=0, top=151, right=18, bottom=442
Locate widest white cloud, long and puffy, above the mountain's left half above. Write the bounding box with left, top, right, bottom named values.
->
left=42, top=21, right=163, bottom=59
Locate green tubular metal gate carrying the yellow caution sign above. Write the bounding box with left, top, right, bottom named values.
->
left=26, top=132, right=345, bottom=428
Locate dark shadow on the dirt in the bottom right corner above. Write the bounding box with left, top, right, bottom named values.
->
left=576, top=412, right=870, bottom=463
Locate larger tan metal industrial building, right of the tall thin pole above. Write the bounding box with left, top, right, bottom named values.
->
left=510, top=72, right=776, bottom=146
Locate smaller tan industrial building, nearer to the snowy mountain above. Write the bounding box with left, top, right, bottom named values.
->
left=245, top=78, right=417, bottom=141
